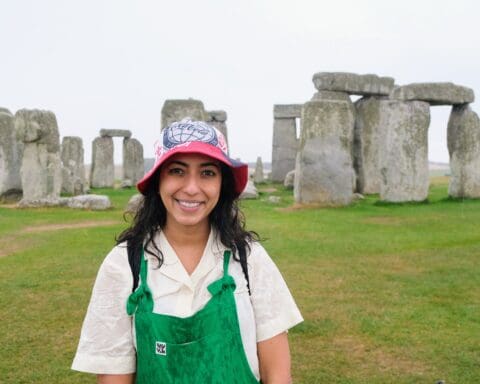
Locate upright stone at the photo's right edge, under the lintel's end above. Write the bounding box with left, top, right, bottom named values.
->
left=447, top=105, right=480, bottom=198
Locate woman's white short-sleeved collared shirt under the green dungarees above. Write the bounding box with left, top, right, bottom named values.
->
left=72, top=230, right=303, bottom=379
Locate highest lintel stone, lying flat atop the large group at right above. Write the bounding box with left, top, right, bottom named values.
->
left=313, top=72, right=395, bottom=96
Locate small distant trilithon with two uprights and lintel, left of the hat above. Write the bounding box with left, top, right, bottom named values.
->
left=90, top=129, right=144, bottom=188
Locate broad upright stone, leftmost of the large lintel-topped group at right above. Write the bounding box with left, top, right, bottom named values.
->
left=294, top=100, right=355, bottom=206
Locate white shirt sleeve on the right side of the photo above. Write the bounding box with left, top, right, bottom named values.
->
left=248, top=243, right=303, bottom=342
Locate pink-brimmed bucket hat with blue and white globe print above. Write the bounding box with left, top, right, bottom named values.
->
left=137, top=119, right=248, bottom=196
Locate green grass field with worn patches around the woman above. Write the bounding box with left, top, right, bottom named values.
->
left=0, top=177, right=480, bottom=384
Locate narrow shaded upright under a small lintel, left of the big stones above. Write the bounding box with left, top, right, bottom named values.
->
left=270, top=119, right=298, bottom=182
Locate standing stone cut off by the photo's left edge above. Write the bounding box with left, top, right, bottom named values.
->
left=0, top=108, right=23, bottom=198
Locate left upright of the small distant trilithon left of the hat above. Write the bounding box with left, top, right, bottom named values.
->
left=90, top=136, right=115, bottom=188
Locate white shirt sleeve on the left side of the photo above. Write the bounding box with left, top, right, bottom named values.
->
left=72, top=245, right=136, bottom=374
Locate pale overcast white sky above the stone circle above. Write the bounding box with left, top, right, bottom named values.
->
left=0, top=0, right=480, bottom=163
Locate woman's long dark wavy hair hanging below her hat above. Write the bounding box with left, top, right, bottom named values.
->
left=116, top=163, right=259, bottom=290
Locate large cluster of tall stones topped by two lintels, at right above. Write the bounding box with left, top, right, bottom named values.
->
left=272, top=72, right=480, bottom=205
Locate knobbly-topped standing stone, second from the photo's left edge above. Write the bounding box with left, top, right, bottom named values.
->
left=15, top=109, right=62, bottom=206
